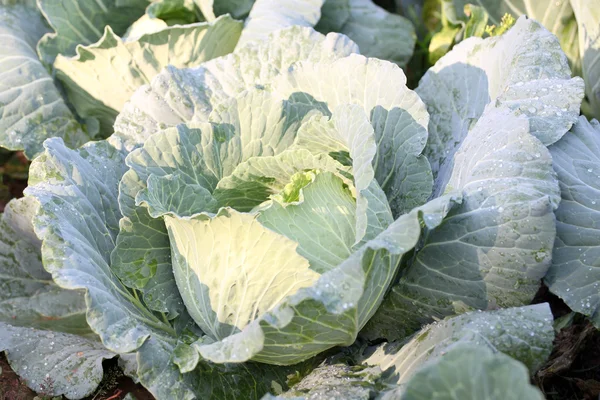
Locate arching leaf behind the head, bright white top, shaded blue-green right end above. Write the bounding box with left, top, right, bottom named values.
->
left=273, top=55, right=432, bottom=217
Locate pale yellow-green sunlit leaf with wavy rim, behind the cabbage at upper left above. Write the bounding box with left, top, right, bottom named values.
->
left=54, top=16, right=242, bottom=136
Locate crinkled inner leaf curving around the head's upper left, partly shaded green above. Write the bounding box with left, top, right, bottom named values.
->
left=112, top=90, right=316, bottom=315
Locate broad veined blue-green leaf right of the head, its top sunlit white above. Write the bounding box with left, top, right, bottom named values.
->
left=366, top=107, right=560, bottom=339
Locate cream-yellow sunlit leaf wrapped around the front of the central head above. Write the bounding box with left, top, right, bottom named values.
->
left=166, top=208, right=322, bottom=342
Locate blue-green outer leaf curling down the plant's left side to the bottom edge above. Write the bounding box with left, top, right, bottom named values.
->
left=27, top=139, right=318, bottom=399
